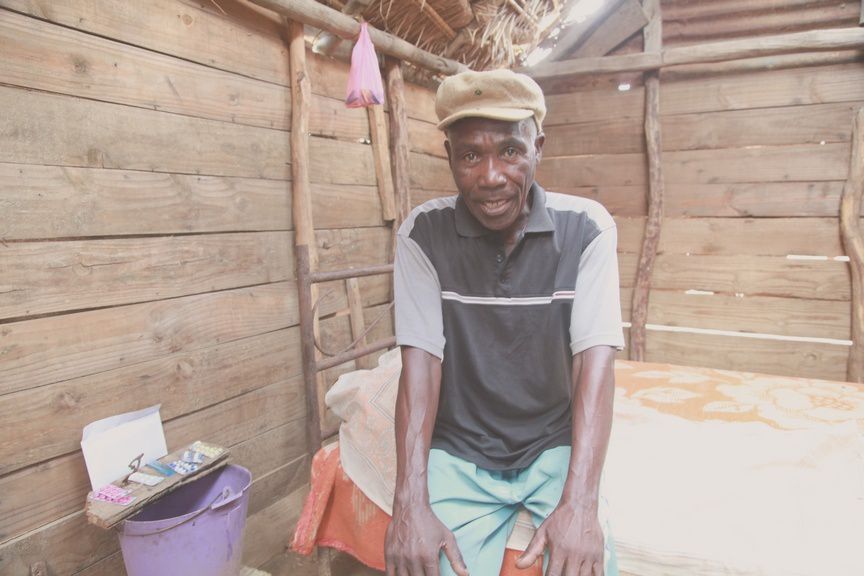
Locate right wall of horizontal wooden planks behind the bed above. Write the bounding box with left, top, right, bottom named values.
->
left=539, top=0, right=864, bottom=380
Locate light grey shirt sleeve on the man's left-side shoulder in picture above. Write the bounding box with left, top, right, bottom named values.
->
left=393, top=233, right=445, bottom=359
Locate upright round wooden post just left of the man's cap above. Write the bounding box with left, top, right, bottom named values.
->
left=385, top=58, right=411, bottom=224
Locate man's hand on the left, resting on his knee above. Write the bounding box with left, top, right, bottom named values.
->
left=384, top=505, right=468, bottom=576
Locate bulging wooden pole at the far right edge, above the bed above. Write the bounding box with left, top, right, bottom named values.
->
left=840, top=108, right=864, bottom=383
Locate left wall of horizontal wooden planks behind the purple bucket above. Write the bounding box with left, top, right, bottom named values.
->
left=0, top=0, right=450, bottom=576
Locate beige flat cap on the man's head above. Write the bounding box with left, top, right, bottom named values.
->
left=435, top=70, right=546, bottom=130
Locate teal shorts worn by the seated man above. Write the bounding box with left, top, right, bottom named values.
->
left=428, top=446, right=618, bottom=576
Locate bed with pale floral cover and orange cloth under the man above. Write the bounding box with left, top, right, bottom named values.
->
left=292, top=258, right=864, bottom=576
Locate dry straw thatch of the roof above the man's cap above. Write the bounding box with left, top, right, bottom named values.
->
left=322, top=0, right=561, bottom=70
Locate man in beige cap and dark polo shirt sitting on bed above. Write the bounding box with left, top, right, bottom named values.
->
left=385, top=70, right=624, bottom=576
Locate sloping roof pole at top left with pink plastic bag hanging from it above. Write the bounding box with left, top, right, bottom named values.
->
left=250, top=0, right=468, bottom=75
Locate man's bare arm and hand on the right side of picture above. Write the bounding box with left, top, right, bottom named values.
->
left=516, top=345, right=615, bottom=576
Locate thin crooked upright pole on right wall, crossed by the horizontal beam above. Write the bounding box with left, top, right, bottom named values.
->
left=629, top=0, right=664, bottom=361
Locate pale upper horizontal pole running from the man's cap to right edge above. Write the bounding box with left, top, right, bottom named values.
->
left=519, top=28, right=864, bottom=80
